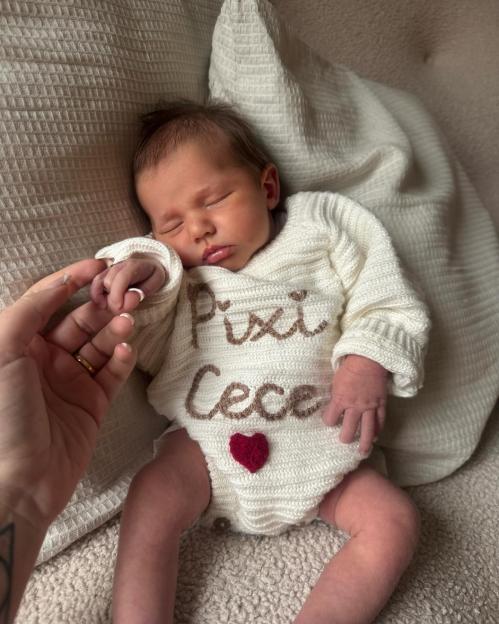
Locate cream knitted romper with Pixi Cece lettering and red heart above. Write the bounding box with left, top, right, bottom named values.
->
left=97, top=193, right=429, bottom=535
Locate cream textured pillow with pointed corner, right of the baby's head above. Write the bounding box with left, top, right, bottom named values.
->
left=210, top=0, right=499, bottom=485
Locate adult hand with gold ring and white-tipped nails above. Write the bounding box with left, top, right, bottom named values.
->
left=0, top=260, right=135, bottom=529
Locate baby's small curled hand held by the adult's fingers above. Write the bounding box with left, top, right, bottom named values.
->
left=90, top=258, right=168, bottom=314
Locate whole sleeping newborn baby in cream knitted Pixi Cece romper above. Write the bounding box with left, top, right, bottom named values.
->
left=91, top=102, right=429, bottom=624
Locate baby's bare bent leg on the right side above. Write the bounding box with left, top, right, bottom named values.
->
left=295, top=467, right=419, bottom=624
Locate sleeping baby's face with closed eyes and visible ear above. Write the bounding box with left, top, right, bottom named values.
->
left=136, top=137, right=279, bottom=271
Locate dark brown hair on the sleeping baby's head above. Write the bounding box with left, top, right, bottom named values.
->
left=132, top=100, right=271, bottom=179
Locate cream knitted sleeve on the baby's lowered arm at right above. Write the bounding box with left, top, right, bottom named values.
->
left=323, top=194, right=430, bottom=397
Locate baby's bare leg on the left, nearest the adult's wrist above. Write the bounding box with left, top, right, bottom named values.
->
left=113, top=429, right=210, bottom=624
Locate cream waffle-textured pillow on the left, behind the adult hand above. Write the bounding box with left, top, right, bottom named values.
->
left=0, top=0, right=220, bottom=559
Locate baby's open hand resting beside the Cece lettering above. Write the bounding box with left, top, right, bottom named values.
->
left=323, top=355, right=388, bottom=453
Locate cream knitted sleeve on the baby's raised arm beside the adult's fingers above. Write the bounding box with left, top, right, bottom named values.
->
left=95, top=236, right=183, bottom=375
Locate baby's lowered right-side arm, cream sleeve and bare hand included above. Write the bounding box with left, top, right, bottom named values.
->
left=308, top=194, right=430, bottom=451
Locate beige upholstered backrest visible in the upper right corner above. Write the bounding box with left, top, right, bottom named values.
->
left=272, top=0, right=499, bottom=231
